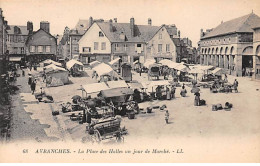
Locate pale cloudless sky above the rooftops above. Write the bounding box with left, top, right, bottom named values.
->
left=0, top=0, right=260, bottom=47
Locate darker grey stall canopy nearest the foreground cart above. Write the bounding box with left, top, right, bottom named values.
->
left=101, top=88, right=134, bottom=97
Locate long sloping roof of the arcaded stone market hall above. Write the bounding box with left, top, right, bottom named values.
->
left=202, top=13, right=260, bottom=39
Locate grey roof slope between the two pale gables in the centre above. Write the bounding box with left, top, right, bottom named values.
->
left=97, top=22, right=161, bottom=42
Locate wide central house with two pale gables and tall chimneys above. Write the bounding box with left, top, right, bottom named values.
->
left=79, top=18, right=179, bottom=64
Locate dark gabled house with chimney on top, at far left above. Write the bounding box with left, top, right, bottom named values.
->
left=26, top=22, right=57, bottom=63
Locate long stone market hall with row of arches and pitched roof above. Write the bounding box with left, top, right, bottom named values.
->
left=199, top=13, right=260, bottom=76
